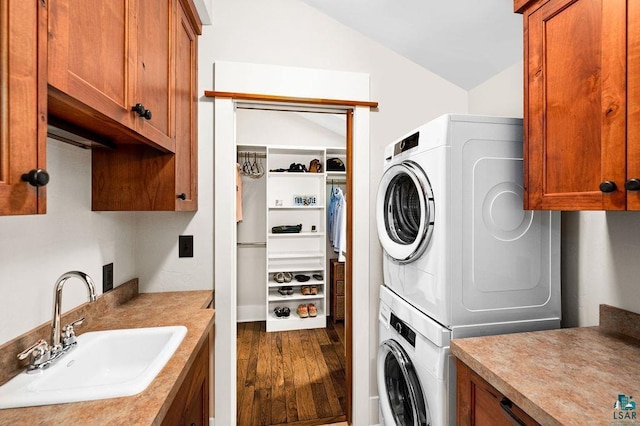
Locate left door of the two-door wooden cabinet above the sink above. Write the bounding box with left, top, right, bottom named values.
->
left=48, top=0, right=135, bottom=128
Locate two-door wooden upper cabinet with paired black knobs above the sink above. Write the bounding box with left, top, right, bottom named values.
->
left=48, top=0, right=175, bottom=152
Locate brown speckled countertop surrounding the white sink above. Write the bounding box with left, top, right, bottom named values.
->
left=0, top=280, right=214, bottom=426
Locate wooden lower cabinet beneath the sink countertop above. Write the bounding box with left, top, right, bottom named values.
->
left=162, top=334, right=211, bottom=426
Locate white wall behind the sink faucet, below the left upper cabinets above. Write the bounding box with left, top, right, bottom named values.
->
left=0, top=140, right=136, bottom=344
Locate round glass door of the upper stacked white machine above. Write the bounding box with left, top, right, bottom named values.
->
left=376, top=161, right=435, bottom=263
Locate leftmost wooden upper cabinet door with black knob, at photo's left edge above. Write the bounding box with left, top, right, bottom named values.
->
left=0, top=0, right=47, bottom=215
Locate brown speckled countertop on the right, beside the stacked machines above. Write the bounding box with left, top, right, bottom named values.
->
left=451, top=305, right=640, bottom=425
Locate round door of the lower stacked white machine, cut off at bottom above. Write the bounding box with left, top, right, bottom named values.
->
left=378, top=340, right=431, bottom=426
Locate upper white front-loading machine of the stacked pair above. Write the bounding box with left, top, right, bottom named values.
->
left=376, top=114, right=560, bottom=337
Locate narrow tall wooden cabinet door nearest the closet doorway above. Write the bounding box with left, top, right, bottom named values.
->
left=175, top=1, right=198, bottom=211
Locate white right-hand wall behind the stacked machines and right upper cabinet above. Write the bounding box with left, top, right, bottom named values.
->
left=469, top=62, right=640, bottom=327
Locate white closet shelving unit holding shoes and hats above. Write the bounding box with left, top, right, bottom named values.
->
left=266, top=146, right=328, bottom=332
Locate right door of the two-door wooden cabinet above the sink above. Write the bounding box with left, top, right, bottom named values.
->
left=131, top=0, right=176, bottom=151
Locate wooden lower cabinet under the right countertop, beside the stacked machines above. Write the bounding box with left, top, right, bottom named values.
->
left=456, top=360, right=538, bottom=426
